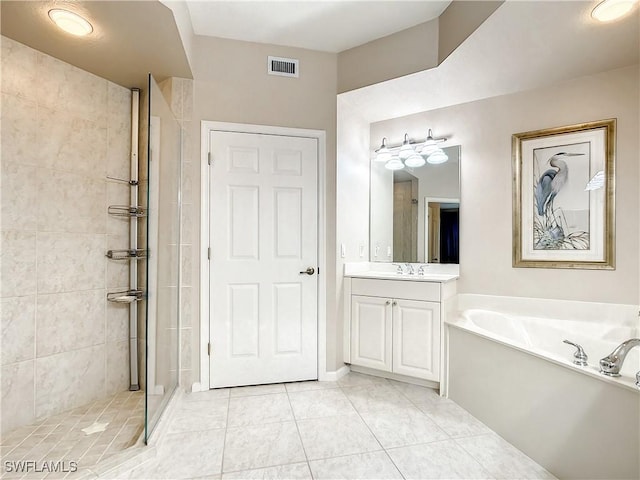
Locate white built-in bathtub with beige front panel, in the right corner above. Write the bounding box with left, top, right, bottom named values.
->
left=444, top=295, right=640, bottom=480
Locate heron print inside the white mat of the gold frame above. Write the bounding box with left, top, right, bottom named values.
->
left=533, top=142, right=590, bottom=250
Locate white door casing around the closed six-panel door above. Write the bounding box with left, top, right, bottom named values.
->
left=191, top=120, right=330, bottom=392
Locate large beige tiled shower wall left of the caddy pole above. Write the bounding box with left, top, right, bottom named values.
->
left=0, top=37, right=131, bottom=432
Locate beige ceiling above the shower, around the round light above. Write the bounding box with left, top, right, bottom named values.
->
left=0, top=0, right=191, bottom=88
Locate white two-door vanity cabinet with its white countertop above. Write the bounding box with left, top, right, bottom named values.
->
left=344, top=263, right=458, bottom=388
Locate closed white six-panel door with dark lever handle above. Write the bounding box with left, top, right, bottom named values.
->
left=209, top=131, right=318, bottom=388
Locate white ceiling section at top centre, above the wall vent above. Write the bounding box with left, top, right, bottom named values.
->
left=186, top=0, right=451, bottom=53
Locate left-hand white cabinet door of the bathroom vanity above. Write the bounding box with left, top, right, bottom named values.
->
left=351, top=295, right=392, bottom=372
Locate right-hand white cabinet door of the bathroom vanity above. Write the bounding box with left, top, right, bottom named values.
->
left=393, top=300, right=440, bottom=382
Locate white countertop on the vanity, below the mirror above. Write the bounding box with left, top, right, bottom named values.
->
left=344, top=262, right=459, bottom=283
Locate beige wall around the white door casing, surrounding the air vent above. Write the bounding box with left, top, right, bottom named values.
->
left=174, top=36, right=342, bottom=387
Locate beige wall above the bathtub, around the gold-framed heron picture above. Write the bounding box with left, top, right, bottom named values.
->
left=360, top=65, right=640, bottom=304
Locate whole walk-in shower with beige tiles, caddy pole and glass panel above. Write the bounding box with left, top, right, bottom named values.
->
left=0, top=37, right=181, bottom=476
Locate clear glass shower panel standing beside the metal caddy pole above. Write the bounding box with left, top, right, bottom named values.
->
left=144, top=75, right=182, bottom=440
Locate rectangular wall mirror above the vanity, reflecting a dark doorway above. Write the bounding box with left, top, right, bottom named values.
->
left=369, top=145, right=461, bottom=263
